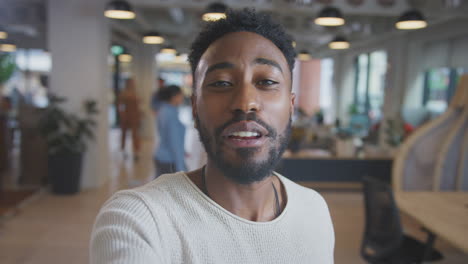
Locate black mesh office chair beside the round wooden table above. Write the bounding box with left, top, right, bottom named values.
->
left=361, top=177, right=442, bottom=264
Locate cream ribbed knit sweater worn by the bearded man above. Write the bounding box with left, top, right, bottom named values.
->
left=90, top=172, right=334, bottom=264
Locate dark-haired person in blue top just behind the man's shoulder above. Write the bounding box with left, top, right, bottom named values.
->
left=154, top=85, right=186, bottom=177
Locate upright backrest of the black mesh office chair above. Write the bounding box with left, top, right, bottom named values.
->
left=361, top=177, right=403, bottom=262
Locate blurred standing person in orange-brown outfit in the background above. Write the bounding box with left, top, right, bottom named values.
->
left=118, top=78, right=141, bottom=161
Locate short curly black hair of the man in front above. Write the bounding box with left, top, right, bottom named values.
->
left=188, top=8, right=296, bottom=85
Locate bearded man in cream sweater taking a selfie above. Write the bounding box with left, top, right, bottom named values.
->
left=91, top=10, right=334, bottom=264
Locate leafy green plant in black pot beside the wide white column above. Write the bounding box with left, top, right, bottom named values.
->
left=39, top=95, right=98, bottom=194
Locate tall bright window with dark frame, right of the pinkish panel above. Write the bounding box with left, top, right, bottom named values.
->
left=354, top=51, right=387, bottom=121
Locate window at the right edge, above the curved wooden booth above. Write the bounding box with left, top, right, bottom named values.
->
left=423, top=67, right=468, bottom=113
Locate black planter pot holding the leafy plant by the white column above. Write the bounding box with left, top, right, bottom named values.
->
left=48, top=151, right=83, bottom=194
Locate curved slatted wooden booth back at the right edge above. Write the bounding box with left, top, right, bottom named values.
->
left=392, top=74, right=468, bottom=191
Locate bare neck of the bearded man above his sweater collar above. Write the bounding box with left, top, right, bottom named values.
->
left=189, top=163, right=285, bottom=222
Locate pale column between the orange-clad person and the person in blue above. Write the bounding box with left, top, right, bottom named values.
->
left=132, top=42, right=158, bottom=139
